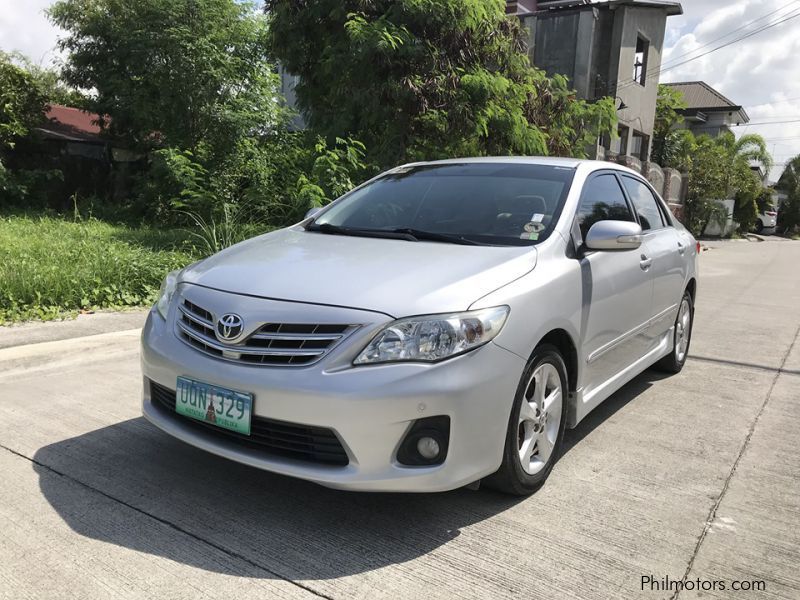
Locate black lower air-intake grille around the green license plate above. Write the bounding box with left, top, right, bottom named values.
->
left=150, top=381, right=350, bottom=467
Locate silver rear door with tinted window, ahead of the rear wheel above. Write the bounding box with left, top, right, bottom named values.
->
left=620, top=174, right=690, bottom=348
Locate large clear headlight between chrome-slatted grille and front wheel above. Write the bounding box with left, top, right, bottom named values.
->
left=353, top=306, right=509, bottom=365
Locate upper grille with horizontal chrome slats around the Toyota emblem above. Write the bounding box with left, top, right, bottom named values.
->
left=178, top=298, right=356, bottom=366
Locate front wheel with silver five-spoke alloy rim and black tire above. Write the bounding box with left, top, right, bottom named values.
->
left=485, top=344, right=569, bottom=496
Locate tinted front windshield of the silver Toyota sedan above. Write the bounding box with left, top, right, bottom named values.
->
left=307, top=163, right=575, bottom=246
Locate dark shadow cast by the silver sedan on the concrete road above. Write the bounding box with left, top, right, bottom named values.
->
left=34, top=372, right=658, bottom=580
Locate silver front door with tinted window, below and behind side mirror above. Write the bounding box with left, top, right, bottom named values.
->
left=576, top=171, right=653, bottom=396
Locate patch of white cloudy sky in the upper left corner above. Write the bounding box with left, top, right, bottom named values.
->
left=0, top=0, right=59, bottom=65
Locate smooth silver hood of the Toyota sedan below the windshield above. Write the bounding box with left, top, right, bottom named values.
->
left=180, top=228, right=536, bottom=317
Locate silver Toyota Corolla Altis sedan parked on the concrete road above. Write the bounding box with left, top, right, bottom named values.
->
left=142, top=158, right=698, bottom=494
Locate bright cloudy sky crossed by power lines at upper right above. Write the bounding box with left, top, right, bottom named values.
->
left=661, top=0, right=800, bottom=179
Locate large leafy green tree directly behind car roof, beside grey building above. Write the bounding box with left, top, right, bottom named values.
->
left=266, top=0, right=616, bottom=167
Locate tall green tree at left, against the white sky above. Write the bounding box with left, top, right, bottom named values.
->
left=49, top=0, right=297, bottom=221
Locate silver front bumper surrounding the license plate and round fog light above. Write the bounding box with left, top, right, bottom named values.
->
left=142, top=296, right=525, bottom=492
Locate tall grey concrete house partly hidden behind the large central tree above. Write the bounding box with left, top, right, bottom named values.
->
left=506, top=0, right=683, bottom=160
